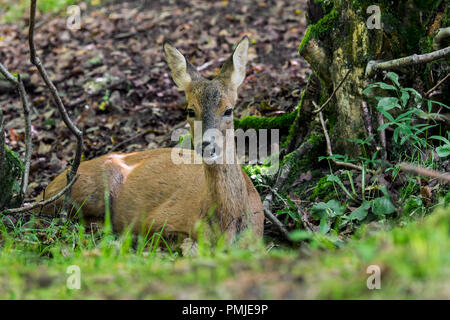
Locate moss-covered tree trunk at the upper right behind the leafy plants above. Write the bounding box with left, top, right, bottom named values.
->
left=299, top=0, right=448, bottom=156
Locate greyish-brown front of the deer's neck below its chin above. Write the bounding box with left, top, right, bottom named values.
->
left=203, top=156, right=250, bottom=235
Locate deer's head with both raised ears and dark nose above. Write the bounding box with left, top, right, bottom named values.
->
left=164, top=36, right=249, bottom=161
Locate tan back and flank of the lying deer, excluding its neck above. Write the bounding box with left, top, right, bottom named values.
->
left=38, top=148, right=264, bottom=234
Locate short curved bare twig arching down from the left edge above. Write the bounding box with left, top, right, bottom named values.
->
left=0, top=63, right=32, bottom=206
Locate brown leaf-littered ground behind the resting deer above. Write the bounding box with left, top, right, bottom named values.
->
left=0, top=1, right=311, bottom=195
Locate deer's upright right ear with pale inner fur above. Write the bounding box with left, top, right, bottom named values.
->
left=219, top=36, right=249, bottom=89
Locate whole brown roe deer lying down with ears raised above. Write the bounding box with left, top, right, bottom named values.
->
left=37, top=37, right=264, bottom=239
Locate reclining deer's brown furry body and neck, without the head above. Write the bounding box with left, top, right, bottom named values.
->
left=37, top=148, right=264, bottom=238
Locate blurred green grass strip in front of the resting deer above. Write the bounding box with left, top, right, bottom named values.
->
left=0, top=207, right=450, bottom=299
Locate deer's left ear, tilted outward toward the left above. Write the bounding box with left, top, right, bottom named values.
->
left=163, top=41, right=201, bottom=90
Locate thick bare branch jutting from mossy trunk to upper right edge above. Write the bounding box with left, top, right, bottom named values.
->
left=366, top=47, right=450, bottom=76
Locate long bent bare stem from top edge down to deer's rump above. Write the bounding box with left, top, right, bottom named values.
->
left=28, top=0, right=83, bottom=219
